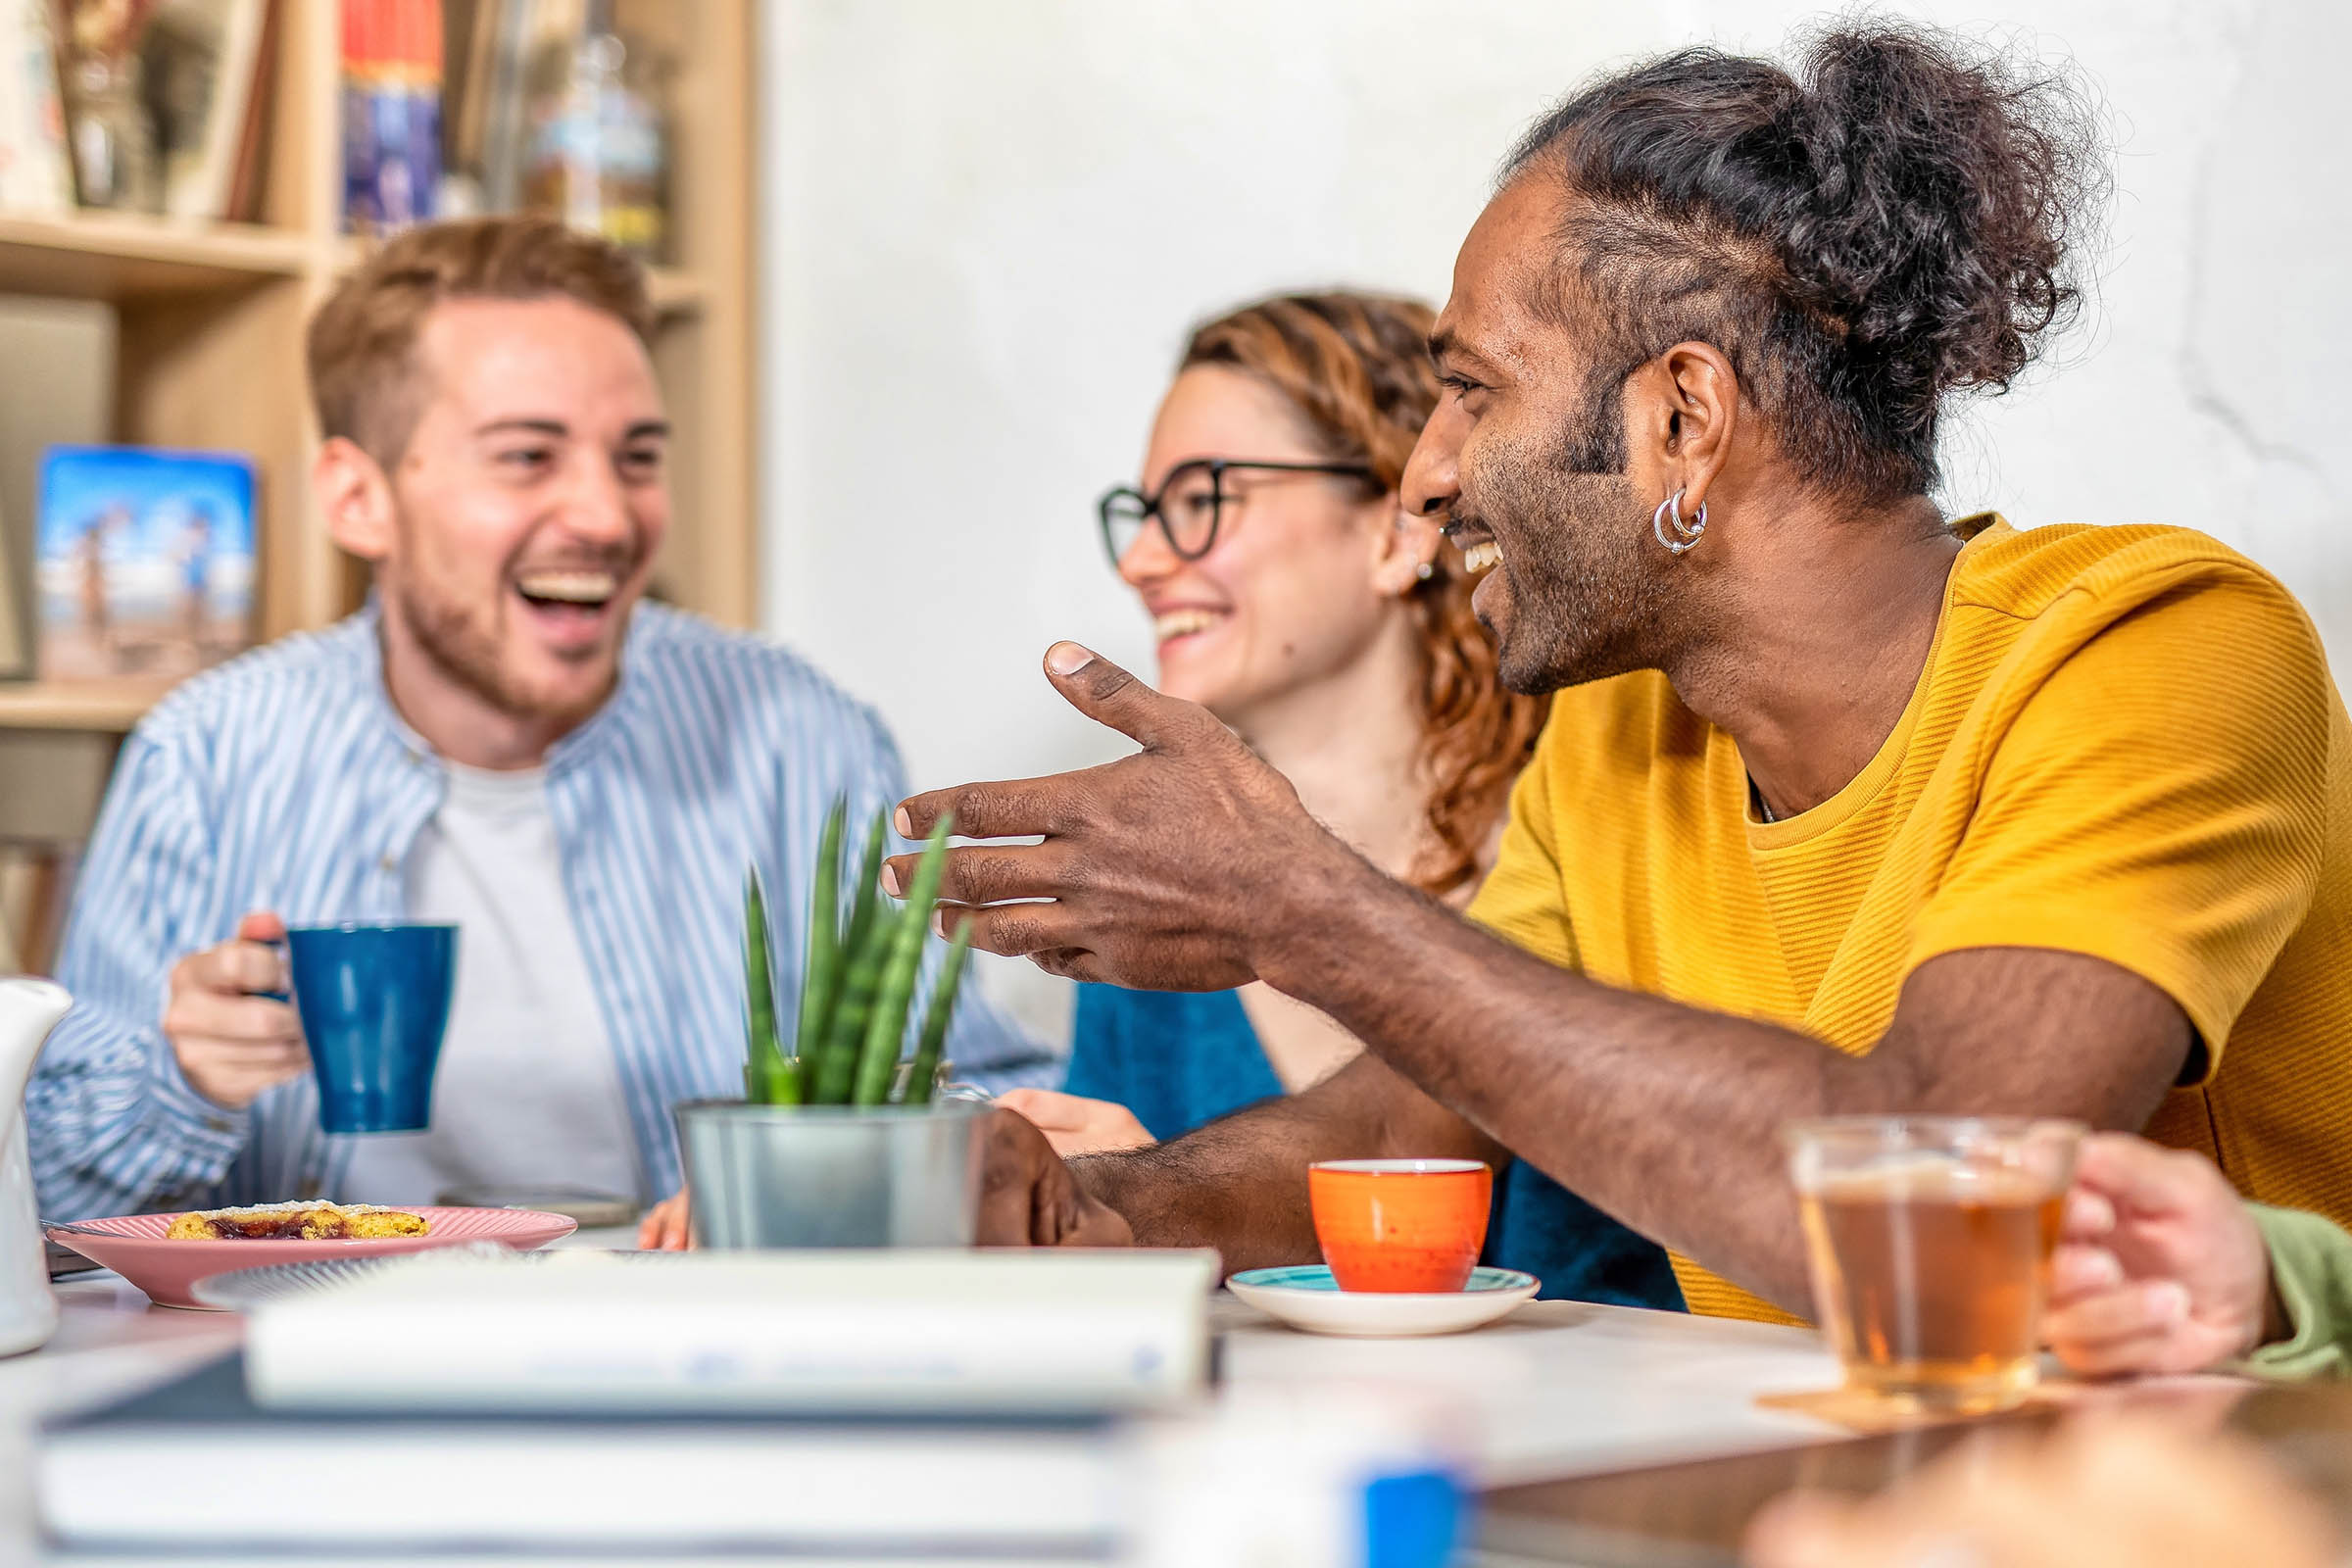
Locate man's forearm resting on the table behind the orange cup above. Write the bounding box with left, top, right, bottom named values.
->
left=1070, top=1055, right=1510, bottom=1272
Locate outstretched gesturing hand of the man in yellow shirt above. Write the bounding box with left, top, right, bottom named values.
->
left=882, top=642, right=1369, bottom=990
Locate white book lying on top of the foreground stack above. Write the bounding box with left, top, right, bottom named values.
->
left=245, top=1250, right=1216, bottom=1415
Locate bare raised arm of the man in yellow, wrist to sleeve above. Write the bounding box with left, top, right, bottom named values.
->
left=1258, top=867, right=2192, bottom=1312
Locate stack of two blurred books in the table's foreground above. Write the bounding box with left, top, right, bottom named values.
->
left=35, top=1250, right=1216, bottom=1558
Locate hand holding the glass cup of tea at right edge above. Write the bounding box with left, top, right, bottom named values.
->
left=2044, top=1133, right=2288, bottom=1378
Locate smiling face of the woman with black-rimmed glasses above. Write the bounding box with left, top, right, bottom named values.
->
left=1119, top=365, right=1411, bottom=729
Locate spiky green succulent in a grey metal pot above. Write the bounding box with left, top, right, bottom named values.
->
left=677, top=800, right=988, bottom=1249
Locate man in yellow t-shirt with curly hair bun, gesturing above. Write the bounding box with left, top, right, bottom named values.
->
left=899, top=22, right=2352, bottom=1316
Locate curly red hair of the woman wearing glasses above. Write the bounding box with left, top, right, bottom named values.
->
left=1176, top=289, right=1545, bottom=896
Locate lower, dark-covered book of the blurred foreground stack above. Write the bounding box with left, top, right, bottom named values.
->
left=33, top=1348, right=1139, bottom=1563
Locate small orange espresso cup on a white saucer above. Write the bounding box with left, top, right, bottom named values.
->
left=1307, top=1159, right=1494, bottom=1293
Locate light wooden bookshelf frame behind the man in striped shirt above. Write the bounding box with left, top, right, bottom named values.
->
left=0, top=0, right=758, bottom=733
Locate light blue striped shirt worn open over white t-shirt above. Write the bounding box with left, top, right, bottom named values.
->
left=25, top=604, right=1058, bottom=1218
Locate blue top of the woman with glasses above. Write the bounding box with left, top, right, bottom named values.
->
left=1063, top=985, right=1682, bottom=1312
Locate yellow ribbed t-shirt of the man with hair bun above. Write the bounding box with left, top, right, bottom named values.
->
left=1470, top=517, right=2352, bottom=1321
